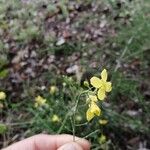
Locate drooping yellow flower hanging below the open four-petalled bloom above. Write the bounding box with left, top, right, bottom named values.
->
left=86, top=101, right=101, bottom=121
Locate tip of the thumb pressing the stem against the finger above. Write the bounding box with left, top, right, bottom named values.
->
left=57, top=142, right=83, bottom=150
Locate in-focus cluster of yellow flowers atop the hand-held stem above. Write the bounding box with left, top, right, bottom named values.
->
left=86, top=69, right=112, bottom=121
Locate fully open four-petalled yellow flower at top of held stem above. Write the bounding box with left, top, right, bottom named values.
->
left=90, top=69, right=112, bottom=100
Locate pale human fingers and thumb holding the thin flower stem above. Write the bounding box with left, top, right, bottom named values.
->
left=2, top=134, right=90, bottom=150
